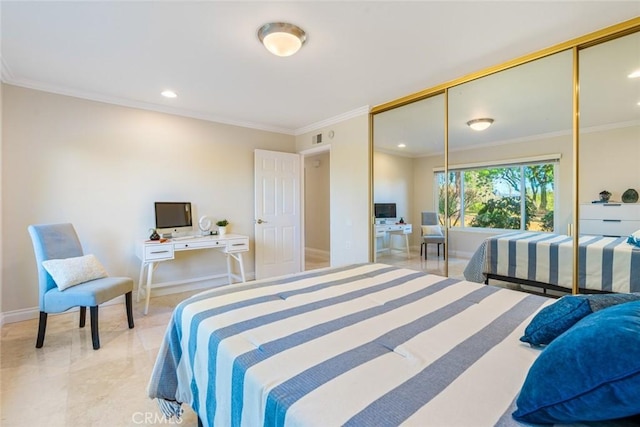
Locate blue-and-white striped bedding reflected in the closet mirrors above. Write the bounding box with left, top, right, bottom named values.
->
left=464, top=232, right=640, bottom=292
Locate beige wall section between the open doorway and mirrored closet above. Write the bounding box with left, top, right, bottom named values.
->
left=296, top=113, right=371, bottom=266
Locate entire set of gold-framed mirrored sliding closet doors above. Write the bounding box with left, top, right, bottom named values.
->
left=371, top=19, right=640, bottom=293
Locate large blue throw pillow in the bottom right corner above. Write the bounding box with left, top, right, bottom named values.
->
left=513, top=301, right=640, bottom=424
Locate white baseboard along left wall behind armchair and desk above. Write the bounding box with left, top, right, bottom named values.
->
left=0, top=273, right=255, bottom=326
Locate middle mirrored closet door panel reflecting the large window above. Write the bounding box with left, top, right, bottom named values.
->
left=448, top=50, right=573, bottom=287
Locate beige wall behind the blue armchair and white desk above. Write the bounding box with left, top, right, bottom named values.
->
left=1, top=85, right=295, bottom=313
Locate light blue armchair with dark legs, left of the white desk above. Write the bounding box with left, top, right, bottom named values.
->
left=28, top=224, right=133, bottom=350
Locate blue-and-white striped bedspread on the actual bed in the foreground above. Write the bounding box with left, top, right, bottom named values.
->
left=148, top=264, right=552, bottom=426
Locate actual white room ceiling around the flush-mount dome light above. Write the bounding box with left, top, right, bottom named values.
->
left=0, top=1, right=640, bottom=135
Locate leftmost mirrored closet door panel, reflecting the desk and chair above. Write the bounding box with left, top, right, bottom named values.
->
left=372, top=94, right=446, bottom=275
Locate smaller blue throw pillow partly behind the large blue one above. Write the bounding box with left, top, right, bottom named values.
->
left=520, top=293, right=640, bottom=347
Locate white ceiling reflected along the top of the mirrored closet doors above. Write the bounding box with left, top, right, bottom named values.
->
left=374, top=32, right=640, bottom=157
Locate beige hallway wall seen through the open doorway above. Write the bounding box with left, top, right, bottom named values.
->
left=304, top=152, right=331, bottom=256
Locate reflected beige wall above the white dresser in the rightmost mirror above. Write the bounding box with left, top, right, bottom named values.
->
left=579, top=126, right=640, bottom=203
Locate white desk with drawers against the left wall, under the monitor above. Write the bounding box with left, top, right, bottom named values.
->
left=137, top=234, right=249, bottom=314
